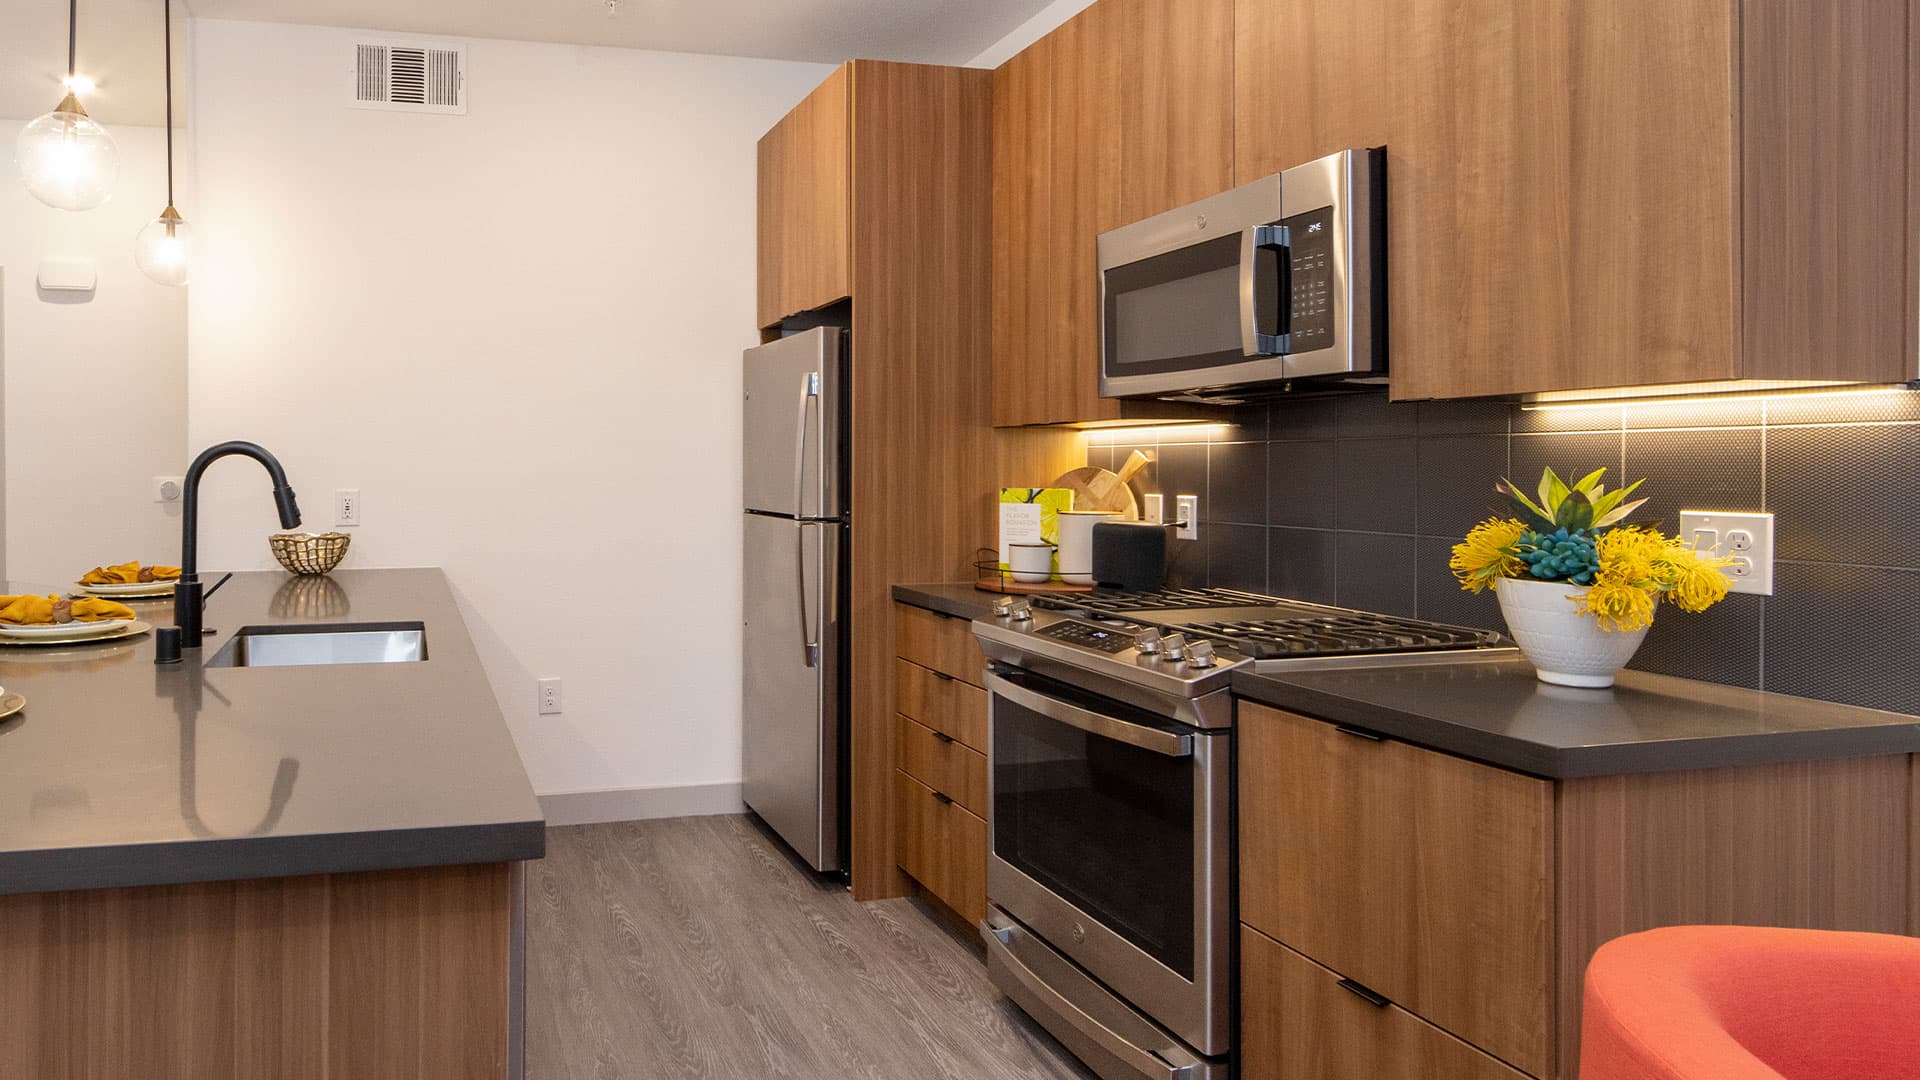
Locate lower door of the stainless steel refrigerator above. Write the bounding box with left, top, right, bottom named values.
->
left=741, top=513, right=845, bottom=871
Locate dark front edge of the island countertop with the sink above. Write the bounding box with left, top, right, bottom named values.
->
left=0, top=819, right=547, bottom=896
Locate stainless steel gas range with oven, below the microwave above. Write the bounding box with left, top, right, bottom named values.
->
left=973, top=590, right=1515, bottom=1080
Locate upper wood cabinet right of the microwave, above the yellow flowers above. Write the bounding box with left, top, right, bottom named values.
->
left=1235, top=0, right=1920, bottom=398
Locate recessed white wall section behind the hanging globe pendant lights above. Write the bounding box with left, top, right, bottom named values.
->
left=0, top=121, right=194, bottom=586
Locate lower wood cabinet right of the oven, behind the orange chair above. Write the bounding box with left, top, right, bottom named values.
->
left=1235, top=701, right=1920, bottom=1080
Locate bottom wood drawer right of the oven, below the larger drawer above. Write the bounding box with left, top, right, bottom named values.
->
left=1240, top=926, right=1526, bottom=1080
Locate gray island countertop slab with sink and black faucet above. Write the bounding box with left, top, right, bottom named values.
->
left=0, top=569, right=545, bottom=894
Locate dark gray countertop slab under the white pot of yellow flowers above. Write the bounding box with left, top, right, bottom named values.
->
left=1233, top=661, right=1920, bottom=780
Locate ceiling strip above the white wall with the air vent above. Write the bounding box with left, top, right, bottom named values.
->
left=192, top=0, right=1046, bottom=63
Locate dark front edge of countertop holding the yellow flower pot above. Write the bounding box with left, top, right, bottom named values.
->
left=1233, top=673, right=1920, bottom=780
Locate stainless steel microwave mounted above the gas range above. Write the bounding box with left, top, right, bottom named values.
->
left=1098, top=150, right=1386, bottom=402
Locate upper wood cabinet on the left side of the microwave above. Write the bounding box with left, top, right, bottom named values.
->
left=993, top=0, right=1233, bottom=425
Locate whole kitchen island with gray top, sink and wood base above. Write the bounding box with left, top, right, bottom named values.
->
left=0, top=569, right=545, bottom=1080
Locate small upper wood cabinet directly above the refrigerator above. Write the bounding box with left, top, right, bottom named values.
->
left=755, top=65, right=852, bottom=329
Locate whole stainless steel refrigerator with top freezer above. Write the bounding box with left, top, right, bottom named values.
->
left=743, top=327, right=849, bottom=871
